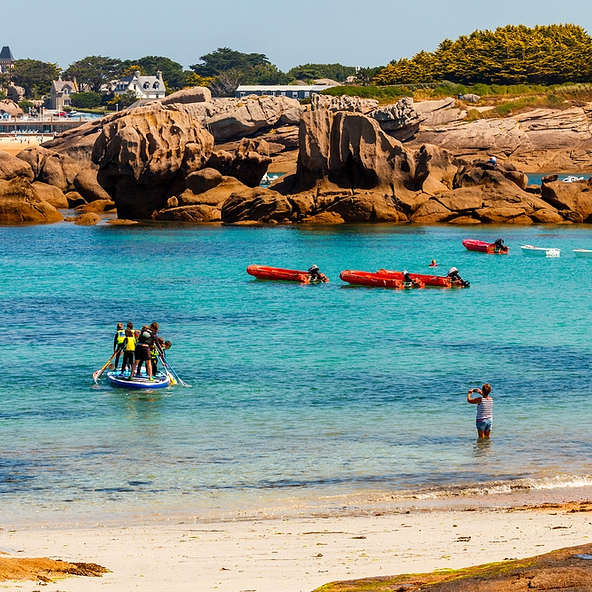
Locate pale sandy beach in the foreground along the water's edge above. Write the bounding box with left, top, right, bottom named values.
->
left=0, top=494, right=592, bottom=592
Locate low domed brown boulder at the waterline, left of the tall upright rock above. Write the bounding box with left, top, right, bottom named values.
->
left=221, top=187, right=292, bottom=223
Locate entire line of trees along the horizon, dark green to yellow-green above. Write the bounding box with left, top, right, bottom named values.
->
left=0, top=24, right=592, bottom=107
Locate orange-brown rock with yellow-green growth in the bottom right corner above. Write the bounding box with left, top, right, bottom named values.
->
left=319, top=544, right=592, bottom=592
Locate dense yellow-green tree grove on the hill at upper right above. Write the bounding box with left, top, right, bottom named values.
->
left=372, top=24, right=592, bottom=85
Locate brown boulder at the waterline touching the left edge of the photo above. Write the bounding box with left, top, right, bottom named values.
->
left=0, top=177, right=64, bottom=224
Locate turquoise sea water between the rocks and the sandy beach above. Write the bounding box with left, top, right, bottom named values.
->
left=0, top=224, right=592, bottom=518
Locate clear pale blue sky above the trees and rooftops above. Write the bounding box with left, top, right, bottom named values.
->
left=0, top=0, right=592, bottom=71
